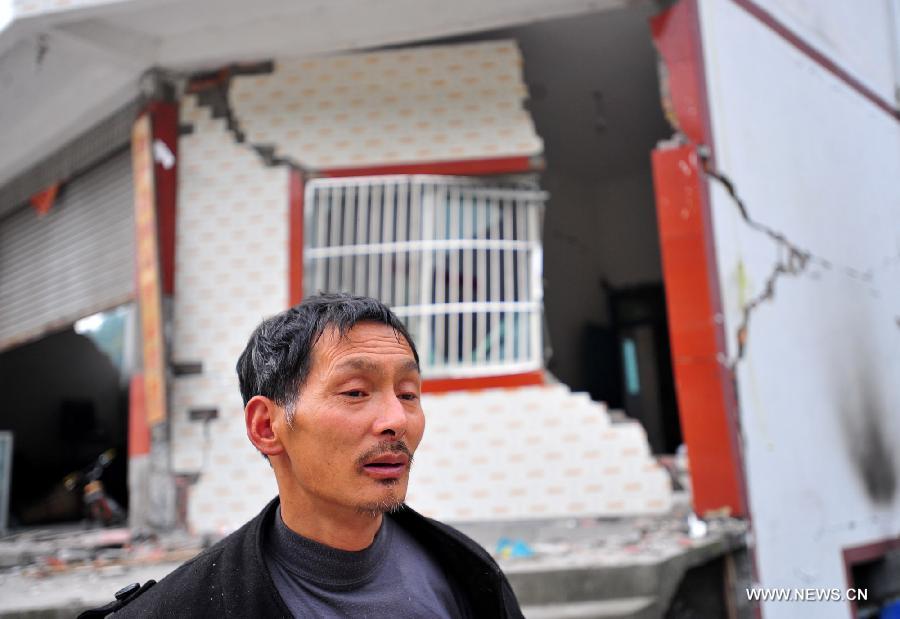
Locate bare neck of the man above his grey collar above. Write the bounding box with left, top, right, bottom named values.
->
left=281, top=493, right=384, bottom=550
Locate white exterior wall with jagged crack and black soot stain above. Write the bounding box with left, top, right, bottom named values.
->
left=700, top=1, right=900, bottom=619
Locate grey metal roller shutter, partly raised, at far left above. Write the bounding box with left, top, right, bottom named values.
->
left=0, top=149, right=134, bottom=350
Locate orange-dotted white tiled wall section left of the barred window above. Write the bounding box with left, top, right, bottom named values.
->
left=171, top=96, right=288, bottom=533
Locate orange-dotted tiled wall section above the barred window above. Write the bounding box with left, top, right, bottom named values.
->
left=230, top=41, right=543, bottom=169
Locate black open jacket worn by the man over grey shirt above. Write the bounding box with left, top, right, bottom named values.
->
left=85, top=498, right=522, bottom=619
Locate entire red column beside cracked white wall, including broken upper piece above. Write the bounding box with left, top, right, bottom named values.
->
left=650, top=0, right=748, bottom=516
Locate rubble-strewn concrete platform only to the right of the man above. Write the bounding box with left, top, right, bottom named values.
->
left=457, top=496, right=749, bottom=619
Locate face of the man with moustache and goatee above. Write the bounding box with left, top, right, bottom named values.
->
left=282, top=322, right=425, bottom=512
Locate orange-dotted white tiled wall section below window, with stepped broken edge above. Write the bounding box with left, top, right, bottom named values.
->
left=407, top=385, right=672, bottom=521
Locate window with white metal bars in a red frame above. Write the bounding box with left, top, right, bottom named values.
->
left=303, top=176, right=547, bottom=378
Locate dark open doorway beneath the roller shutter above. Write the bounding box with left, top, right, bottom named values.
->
left=0, top=306, right=133, bottom=527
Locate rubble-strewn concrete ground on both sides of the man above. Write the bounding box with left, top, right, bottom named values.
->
left=0, top=500, right=745, bottom=619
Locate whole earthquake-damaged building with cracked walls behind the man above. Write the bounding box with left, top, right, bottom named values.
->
left=0, top=0, right=900, bottom=617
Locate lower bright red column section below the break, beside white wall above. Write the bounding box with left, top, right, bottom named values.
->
left=653, top=146, right=747, bottom=516
